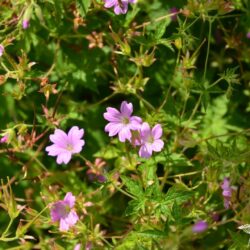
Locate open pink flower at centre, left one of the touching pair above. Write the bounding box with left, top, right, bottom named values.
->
left=104, top=101, right=142, bottom=142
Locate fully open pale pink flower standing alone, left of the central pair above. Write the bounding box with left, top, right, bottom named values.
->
left=45, top=126, right=85, bottom=164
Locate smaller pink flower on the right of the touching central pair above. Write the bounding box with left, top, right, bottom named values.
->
left=139, top=122, right=164, bottom=158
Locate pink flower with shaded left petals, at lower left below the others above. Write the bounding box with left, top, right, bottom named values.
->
left=50, top=192, right=79, bottom=231
